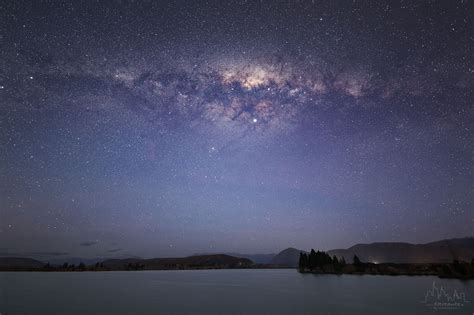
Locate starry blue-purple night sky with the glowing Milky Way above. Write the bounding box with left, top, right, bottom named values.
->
left=0, top=0, right=474, bottom=259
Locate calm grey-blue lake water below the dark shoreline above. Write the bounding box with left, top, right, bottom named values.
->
left=0, top=269, right=474, bottom=315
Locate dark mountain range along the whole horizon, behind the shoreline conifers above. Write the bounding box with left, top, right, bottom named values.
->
left=0, top=237, right=474, bottom=270
